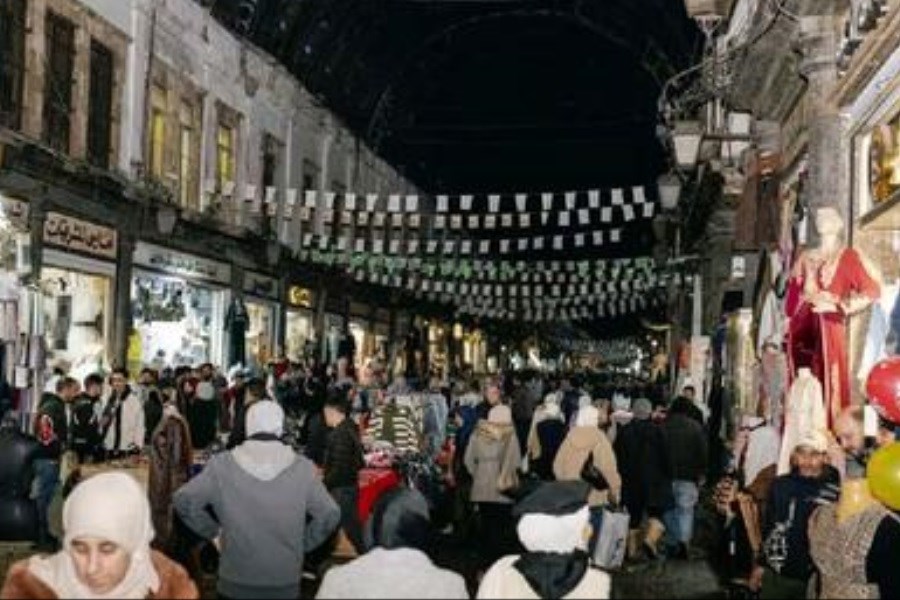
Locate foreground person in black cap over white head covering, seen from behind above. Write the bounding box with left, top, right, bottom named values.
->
left=477, top=481, right=610, bottom=599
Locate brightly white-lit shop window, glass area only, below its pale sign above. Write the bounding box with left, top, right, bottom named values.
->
left=132, top=276, right=225, bottom=366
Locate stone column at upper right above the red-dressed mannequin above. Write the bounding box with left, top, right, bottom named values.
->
left=798, top=14, right=849, bottom=244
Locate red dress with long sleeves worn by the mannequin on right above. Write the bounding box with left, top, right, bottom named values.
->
left=788, top=248, right=881, bottom=428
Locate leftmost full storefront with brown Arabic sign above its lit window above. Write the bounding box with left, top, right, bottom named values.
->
left=41, top=212, right=117, bottom=380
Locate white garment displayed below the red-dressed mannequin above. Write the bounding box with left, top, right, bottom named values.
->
left=778, top=367, right=828, bottom=475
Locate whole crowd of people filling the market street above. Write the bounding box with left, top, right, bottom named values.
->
left=0, top=354, right=900, bottom=598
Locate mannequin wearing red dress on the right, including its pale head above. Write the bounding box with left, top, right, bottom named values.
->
left=788, top=208, right=881, bottom=428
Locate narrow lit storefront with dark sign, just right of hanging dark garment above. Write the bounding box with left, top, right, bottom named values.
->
left=244, top=271, right=279, bottom=368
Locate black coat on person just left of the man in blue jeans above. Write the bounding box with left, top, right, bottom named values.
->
left=613, top=420, right=673, bottom=518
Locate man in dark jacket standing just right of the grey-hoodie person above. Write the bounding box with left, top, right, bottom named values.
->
left=322, top=392, right=365, bottom=554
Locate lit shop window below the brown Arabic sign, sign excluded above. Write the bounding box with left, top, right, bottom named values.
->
left=41, top=267, right=112, bottom=380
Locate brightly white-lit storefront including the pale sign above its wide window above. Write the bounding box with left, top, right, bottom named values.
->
left=132, top=242, right=231, bottom=368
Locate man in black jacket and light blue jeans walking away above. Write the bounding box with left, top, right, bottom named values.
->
left=663, top=398, right=707, bottom=558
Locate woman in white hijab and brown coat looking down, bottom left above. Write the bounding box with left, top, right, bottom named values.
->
left=0, top=472, right=200, bottom=600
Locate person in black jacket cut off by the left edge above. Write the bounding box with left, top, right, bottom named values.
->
left=0, top=412, right=41, bottom=542
